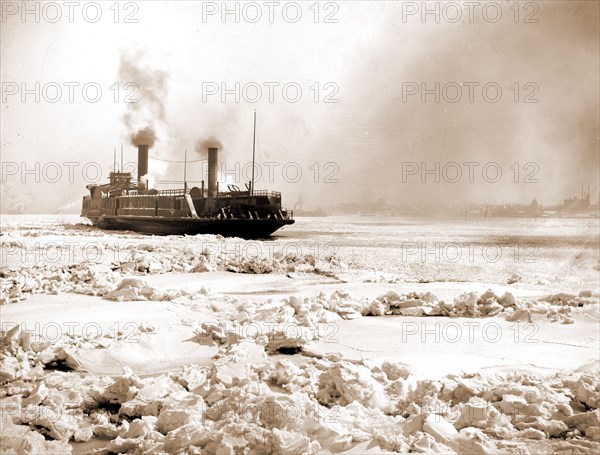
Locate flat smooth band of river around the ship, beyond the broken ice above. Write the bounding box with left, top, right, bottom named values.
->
left=2, top=215, right=600, bottom=288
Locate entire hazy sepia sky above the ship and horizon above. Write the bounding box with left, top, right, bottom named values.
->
left=0, top=1, right=600, bottom=212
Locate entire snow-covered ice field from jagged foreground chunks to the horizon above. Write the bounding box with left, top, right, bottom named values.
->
left=0, top=217, right=600, bottom=454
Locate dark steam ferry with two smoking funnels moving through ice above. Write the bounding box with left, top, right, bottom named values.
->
left=81, top=117, right=294, bottom=239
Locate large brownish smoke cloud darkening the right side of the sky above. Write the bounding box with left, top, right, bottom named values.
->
left=325, top=2, right=599, bottom=204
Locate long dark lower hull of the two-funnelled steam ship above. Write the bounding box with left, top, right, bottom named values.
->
left=92, top=215, right=294, bottom=239
